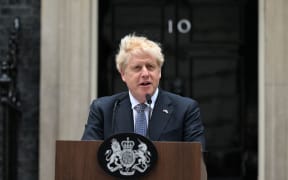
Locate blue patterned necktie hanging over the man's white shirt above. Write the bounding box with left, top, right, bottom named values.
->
left=134, top=104, right=147, bottom=136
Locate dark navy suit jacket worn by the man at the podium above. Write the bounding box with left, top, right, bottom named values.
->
left=82, top=89, right=205, bottom=151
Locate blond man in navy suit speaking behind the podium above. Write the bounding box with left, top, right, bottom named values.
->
left=82, top=35, right=205, bottom=179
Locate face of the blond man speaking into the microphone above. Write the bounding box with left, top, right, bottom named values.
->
left=121, top=55, right=161, bottom=103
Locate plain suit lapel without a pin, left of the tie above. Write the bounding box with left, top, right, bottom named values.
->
left=115, top=96, right=134, bottom=132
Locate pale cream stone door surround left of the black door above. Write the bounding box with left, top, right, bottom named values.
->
left=39, top=0, right=98, bottom=180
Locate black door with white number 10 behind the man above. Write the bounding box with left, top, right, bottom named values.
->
left=98, top=0, right=258, bottom=179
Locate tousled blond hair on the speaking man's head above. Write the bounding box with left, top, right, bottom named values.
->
left=116, top=34, right=164, bottom=72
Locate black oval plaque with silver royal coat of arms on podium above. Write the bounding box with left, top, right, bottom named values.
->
left=98, top=133, right=157, bottom=177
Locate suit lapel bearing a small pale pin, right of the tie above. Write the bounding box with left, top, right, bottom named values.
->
left=149, top=91, right=173, bottom=141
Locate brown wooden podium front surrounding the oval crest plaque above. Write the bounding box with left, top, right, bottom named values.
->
left=55, top=141, right=202, bottom=180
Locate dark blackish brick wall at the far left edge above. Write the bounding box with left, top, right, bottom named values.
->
left=0, top=0, right=41, bottom=180
